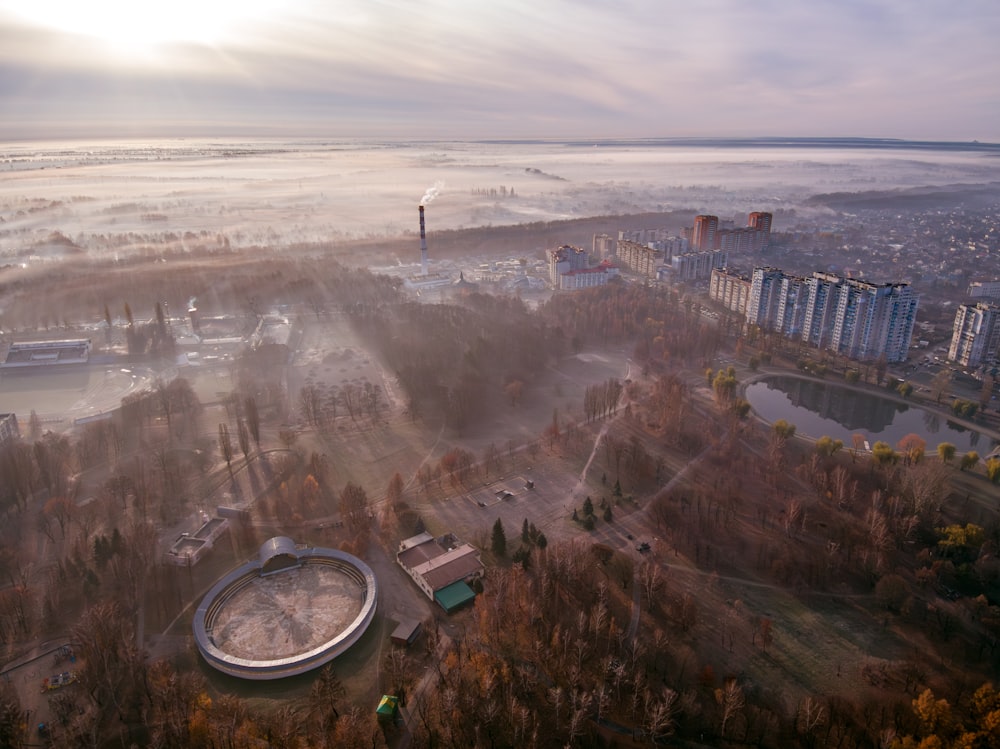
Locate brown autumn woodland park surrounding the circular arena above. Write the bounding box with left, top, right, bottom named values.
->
left=0, top=253, right=1000, bottom=749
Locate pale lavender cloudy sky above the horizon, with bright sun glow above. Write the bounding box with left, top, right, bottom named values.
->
left=0, top=0, right=1000, bottom=142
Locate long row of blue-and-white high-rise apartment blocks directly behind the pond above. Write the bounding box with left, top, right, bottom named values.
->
left=709, top=267, right=919, bottom=362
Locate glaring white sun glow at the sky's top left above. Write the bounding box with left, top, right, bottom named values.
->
left=4, top=0, right=281, bottom=52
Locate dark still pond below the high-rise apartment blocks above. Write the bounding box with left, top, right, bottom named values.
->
left=744, top=375, right=997, bottom=455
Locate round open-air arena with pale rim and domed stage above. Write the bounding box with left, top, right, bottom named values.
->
left=194, top=536, right=378, bottom=680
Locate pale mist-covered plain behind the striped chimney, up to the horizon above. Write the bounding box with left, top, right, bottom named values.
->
left=0, top=139, right=1000, bottom=259
